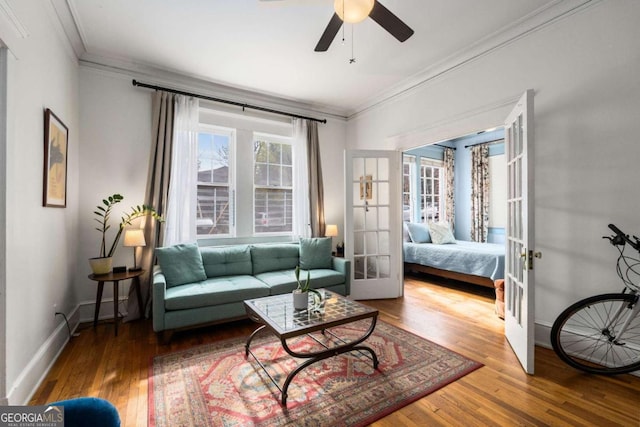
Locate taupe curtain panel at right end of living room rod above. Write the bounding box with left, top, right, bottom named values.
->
left=307, top=120, right=325, bottom=237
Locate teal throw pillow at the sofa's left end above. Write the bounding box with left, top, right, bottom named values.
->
left=156, top=243, right=207, bottom=287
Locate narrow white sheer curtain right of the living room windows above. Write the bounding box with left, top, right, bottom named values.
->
left=293, top=118, right=311, bottom=240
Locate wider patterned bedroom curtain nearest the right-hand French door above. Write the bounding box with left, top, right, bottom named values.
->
left=471, top=144, right=489, bottom=243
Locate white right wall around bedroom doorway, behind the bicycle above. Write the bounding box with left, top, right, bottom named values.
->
left=347, top=0, right=640, bottom=340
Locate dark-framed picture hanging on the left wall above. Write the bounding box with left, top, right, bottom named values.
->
left=42, top=108, right=69, bottom=208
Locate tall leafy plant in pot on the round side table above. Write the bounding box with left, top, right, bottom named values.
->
left=89, top=194, right=164, bottom=274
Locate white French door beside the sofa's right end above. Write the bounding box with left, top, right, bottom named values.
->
left=345, top=150, right=403, bottom=299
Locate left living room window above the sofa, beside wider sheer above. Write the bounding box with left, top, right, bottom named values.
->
left=196, top=126, right=235, bottom=237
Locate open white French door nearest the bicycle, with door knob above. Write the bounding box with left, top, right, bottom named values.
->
left=505, top=90, right=539, bottom=374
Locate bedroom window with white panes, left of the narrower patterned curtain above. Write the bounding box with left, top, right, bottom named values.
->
left=419, top=158, right=446, bottom=223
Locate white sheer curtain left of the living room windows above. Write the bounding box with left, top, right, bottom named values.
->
left=163, top=96, right=199, bottom=246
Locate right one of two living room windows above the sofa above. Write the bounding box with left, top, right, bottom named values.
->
left=253, top=134, right=293, bottom=234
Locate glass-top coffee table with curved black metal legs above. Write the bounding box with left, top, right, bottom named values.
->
left=244, top=289, right=378, bottom=405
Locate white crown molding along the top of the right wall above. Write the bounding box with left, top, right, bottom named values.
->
left=347, top=0, right=603, bottom=120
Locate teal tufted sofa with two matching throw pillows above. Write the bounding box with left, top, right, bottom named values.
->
left=152, top=238, right=351, bottom=340
